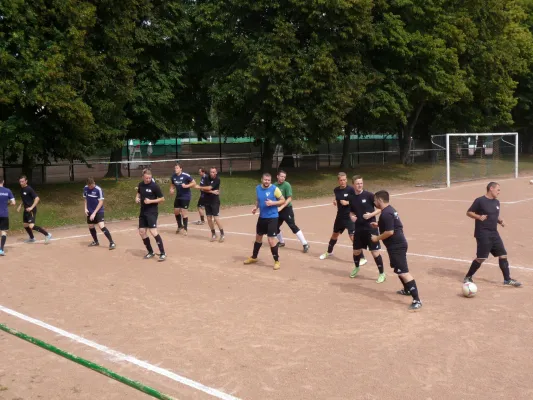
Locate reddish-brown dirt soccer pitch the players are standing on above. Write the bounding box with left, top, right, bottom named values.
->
left=0, top=177, right=533, bottom=400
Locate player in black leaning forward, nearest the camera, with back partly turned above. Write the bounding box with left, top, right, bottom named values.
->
left=371, top=190, right=422, bottom=311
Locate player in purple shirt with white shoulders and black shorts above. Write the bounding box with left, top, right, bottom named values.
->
left=83, top=178, right=117, bottom=250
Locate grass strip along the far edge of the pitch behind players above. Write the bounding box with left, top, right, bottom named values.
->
left=4, top=157, right=533, bottom=231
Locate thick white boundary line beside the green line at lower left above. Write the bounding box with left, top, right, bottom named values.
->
left=0, top=305, right=239, bottom=400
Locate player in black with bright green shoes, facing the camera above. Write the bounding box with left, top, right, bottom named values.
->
left=350, top=175, right=387, bottom=283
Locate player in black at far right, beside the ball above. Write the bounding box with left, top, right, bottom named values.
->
left=464, top=182, right=522, bottom=287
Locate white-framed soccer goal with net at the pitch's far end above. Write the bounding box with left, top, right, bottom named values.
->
left=431, top=132, right=518, bottom=187
